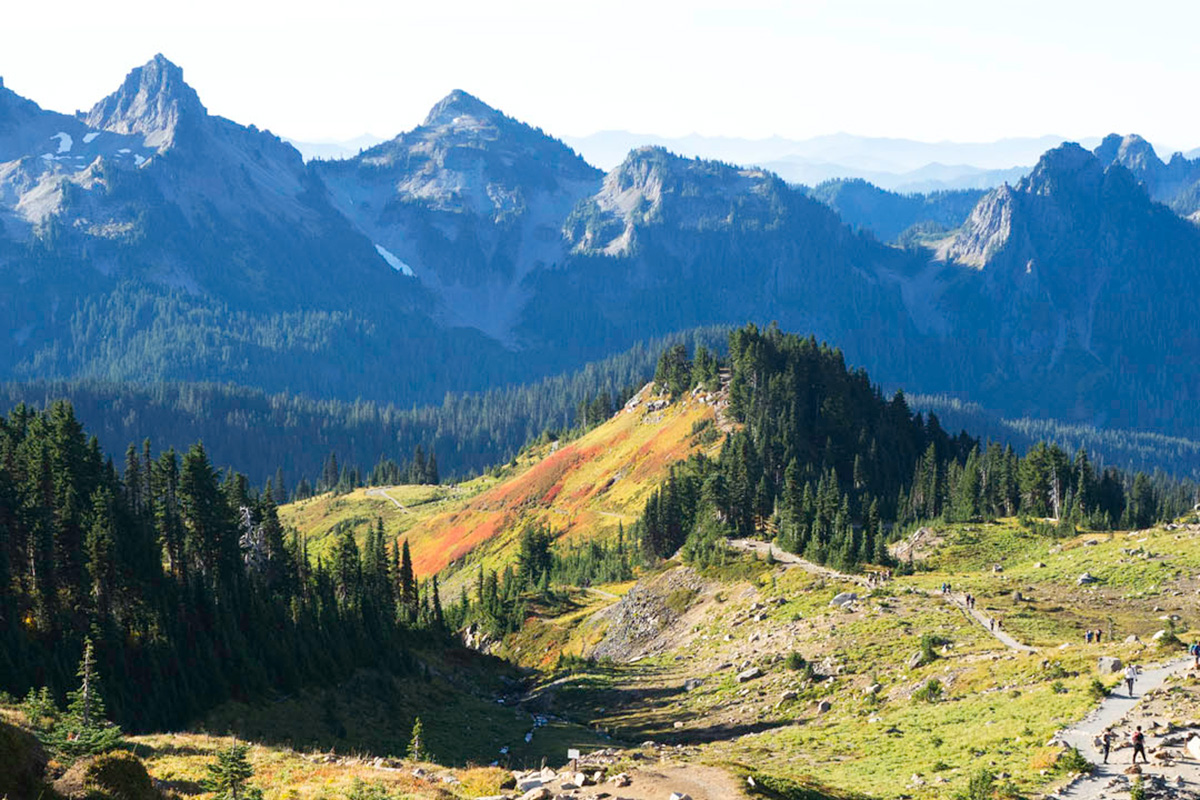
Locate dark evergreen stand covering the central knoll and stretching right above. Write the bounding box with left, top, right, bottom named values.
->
left=635, top=326, right=1195, bottom=570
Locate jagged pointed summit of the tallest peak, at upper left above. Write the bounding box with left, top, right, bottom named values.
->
left=84, top=53, right=208, bottom=148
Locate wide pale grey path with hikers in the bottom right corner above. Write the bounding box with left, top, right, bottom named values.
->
left=1057, top=657, right=1200, bottom=800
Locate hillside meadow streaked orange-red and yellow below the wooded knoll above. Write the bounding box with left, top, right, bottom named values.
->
left=281, top=383, right=720, bottom=585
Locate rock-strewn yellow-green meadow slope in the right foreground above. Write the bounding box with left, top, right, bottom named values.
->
left=508, top=521, right=1200, bottom=798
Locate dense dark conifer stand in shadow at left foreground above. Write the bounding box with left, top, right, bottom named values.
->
left=0, top=403, right=443, bottom=729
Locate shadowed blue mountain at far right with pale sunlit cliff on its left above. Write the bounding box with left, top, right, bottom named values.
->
left=943, top=143, right=1200, bottom=429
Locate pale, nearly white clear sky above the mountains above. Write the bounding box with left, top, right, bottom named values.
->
left=0, top=0, right=1200, bottom=150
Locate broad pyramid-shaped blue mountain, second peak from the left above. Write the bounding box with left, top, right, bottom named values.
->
left=312, top=91, right=600, bottom=341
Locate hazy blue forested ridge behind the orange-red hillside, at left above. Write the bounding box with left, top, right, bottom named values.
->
left=0, top=327, right=726, bottom=497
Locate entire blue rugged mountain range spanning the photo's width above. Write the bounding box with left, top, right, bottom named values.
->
left=0, top=56, right=1200, bottom=435
